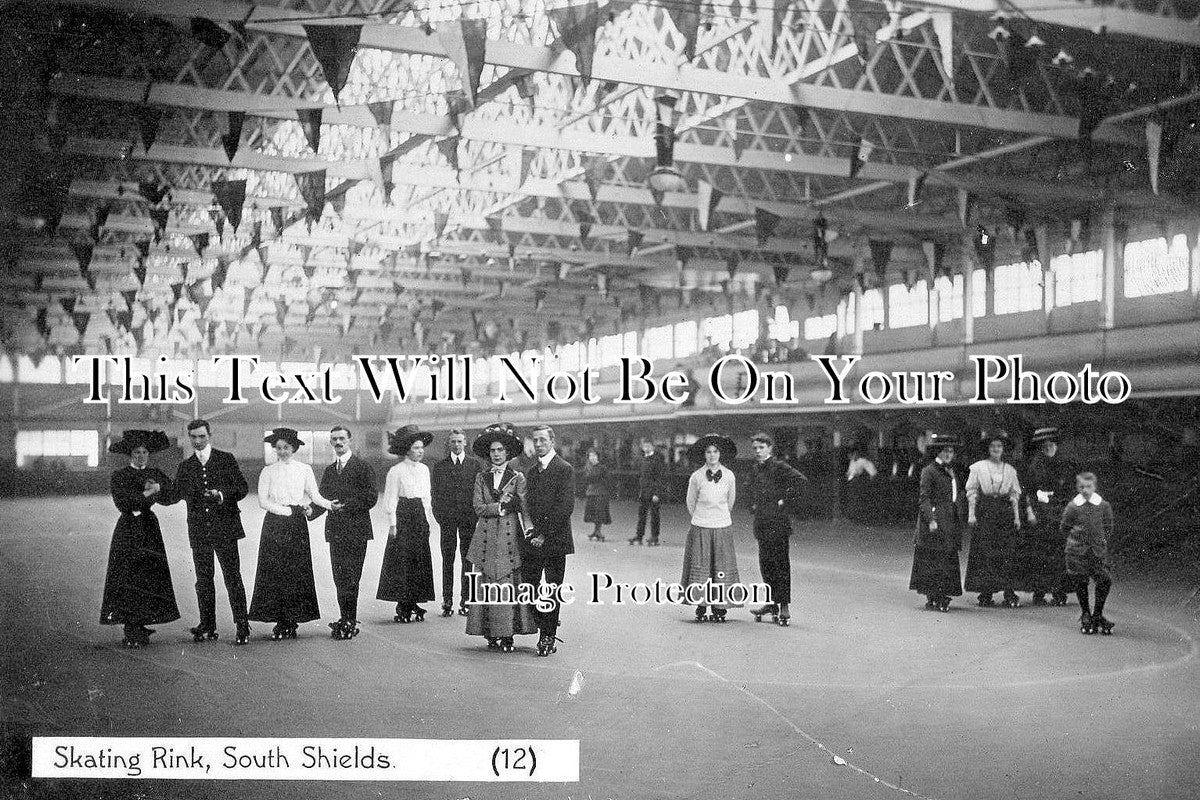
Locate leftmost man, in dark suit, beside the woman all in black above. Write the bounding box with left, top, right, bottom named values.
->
left=170, top=420, right=250, bottom=644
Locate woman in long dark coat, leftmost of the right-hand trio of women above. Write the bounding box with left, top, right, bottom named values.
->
left=908, top=433, right=966, bottom=612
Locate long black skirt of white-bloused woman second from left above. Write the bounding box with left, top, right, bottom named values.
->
left=250, top=506, right=320, bottom=624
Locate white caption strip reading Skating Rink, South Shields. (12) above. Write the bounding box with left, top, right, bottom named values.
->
left=34, top=736, right=580, bottom=783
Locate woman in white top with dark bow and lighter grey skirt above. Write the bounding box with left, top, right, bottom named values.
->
left=680, top=433, right=742, bottom=622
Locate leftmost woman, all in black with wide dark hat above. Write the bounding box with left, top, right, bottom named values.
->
left=100, top=431, right=179, bottom=648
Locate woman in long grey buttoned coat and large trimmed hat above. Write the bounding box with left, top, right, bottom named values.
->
left=467, top=423, right=538, bottom=652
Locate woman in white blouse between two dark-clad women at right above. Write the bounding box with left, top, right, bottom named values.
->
left=965, top=431, right=1021, bottom=608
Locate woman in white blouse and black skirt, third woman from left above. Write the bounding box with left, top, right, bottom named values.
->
left=376, top=425, right=433, bottom=622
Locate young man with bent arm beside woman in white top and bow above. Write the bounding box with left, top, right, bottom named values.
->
left=750, top=433, right=808, bottom=625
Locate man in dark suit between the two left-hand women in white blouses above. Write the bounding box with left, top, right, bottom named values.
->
left=320, top=425, right=379, bottom=640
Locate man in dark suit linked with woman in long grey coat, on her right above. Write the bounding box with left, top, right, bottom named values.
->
left=521, top=425, right=575, bottom=656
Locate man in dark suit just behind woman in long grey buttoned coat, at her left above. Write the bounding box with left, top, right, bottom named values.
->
left=430, top=428, right=480, bottom=616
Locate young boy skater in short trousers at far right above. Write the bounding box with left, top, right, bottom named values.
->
left=1058, top=473, right=1112, bottom=636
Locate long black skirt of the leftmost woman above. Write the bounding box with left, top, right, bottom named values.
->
left=100, top=512, right=179, bottom=625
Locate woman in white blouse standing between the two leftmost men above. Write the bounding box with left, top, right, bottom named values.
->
left=250, top=428, right=334, bottom=639
